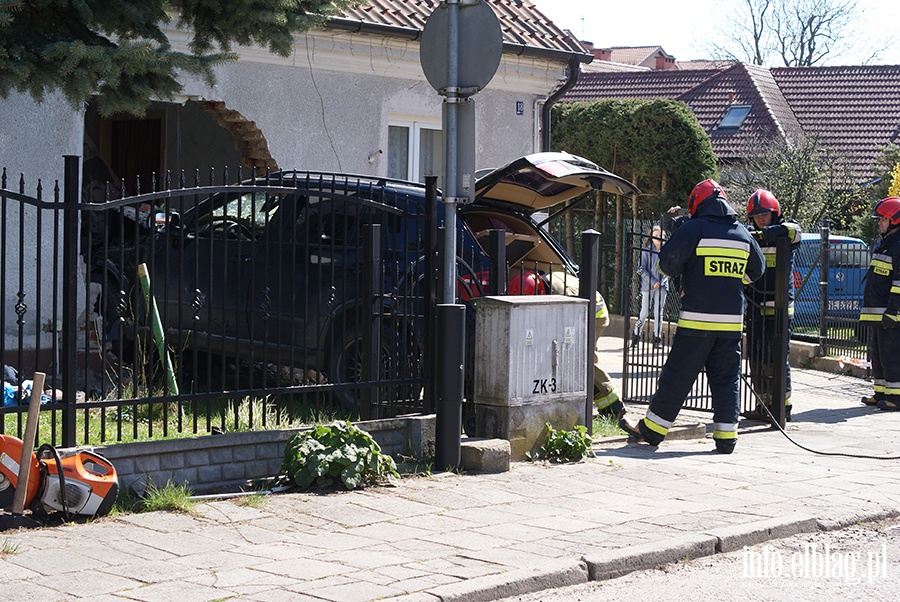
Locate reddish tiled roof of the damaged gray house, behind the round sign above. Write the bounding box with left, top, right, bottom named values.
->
left=340, top=0, right=584, bottom=54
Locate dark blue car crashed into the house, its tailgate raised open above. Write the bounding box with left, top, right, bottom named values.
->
left=91, top=153, right=635, bottom=404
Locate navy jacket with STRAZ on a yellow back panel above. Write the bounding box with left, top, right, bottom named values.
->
left=659, top=198, right=766, bottom=339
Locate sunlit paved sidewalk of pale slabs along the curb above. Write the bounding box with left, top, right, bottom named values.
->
left=0, top=337, right=900, bottom=602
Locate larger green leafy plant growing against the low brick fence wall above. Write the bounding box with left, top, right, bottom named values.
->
left=279, top=422, right=399, bottom=489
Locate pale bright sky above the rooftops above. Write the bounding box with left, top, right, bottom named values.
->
left=531, top=0, right=900, bottom=66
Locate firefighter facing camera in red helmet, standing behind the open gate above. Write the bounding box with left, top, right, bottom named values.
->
left=744, top=189, right=801, bottom=422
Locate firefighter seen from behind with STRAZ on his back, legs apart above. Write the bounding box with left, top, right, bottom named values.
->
left=620, top=180, right=765, bottom=454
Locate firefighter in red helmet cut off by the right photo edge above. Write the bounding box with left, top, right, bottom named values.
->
left=859, top=197, right=900, bottom=411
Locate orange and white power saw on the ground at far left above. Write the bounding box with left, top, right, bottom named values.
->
left=0, top=435, right=119, bottom=516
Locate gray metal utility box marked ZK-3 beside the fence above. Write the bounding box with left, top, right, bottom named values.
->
left=474, top=295, right=593, bottom=460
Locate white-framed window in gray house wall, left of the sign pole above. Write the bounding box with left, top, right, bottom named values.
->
left=388, top=121, right=444, bottom=187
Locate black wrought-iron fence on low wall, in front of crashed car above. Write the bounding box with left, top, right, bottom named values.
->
left=0, top=157, right=436, bottom=445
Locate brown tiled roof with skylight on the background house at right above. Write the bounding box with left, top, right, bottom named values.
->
left=563, top=63, right=900, bottom=181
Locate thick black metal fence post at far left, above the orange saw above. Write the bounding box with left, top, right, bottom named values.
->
left=61, top=155, right=81, bottom=447
